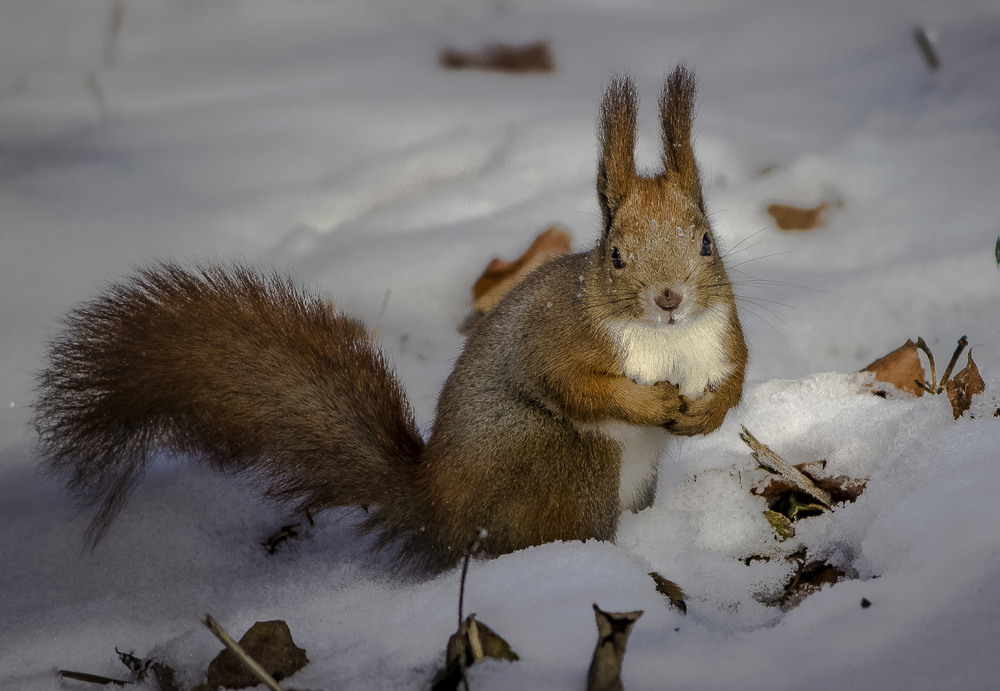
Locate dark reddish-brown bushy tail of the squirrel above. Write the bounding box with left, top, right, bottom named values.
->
left=35, top=264, right=423, bottom=545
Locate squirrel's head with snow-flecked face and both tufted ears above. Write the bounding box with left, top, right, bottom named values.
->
left=595, top=65, right=733, bottom=324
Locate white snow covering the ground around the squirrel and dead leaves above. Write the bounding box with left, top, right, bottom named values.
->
left=0, top=0, right=1000, bottom=691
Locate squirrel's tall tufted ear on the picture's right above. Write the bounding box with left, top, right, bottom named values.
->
left=660, top=65, right=705, bottom=213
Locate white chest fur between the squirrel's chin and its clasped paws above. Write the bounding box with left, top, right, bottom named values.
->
left=608, top=305, right=733, bottom=397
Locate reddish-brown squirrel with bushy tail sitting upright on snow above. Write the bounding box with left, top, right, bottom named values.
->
left=35, top=66, right=747, bottom=571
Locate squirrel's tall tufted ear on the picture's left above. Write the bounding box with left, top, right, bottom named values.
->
left=597, top=75, right=639, bottom=233
